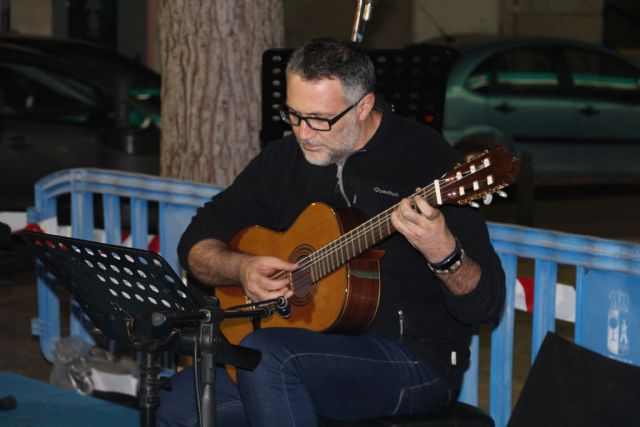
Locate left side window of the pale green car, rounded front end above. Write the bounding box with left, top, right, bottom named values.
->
left=466, top=48, right=560, bottom=94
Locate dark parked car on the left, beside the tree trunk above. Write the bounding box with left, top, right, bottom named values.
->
left=0, top=42, right=160, bottom=211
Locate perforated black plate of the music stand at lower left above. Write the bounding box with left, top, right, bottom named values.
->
left=22, top=231, right=206, bottom=341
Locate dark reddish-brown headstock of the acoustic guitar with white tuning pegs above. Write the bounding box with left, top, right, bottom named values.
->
left=438, top=148, right=520, bottom=205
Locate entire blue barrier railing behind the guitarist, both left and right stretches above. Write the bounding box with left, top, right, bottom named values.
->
left=29, top=169, right=640, bottom=427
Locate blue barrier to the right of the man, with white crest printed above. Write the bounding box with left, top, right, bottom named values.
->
left=472, top=223, right=640, bottom=426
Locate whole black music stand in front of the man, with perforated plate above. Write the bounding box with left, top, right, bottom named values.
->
left=22, top=231, right=262, bottom=427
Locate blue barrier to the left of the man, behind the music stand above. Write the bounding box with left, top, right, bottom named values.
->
left=28, top=169, right=221, bottom=361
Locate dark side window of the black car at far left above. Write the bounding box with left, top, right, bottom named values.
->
left=0, top=61, right=97, bottom=122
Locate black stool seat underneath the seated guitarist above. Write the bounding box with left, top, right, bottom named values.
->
left=318, top=402, right=495, bottom=427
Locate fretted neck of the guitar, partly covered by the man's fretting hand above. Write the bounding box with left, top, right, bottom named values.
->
left=307, top=180, right=442, bottom=281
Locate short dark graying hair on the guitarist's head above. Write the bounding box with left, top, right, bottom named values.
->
left=287, top=38, right=376, bottom=103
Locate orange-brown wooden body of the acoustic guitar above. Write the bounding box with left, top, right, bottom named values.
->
left=216, top=203, right=384, bottom=344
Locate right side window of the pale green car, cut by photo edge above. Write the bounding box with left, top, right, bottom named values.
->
left=563, top=49, right=640, bottom=100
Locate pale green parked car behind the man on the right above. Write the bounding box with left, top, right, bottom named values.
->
left=412, top=35, right=640, bottom=184
